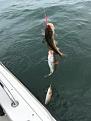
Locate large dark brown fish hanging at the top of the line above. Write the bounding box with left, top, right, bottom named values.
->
left=45, top=23, right=63, bottom=57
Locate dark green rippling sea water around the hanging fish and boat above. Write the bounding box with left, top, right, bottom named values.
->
left=0, top=0, right=91, bottom=121
